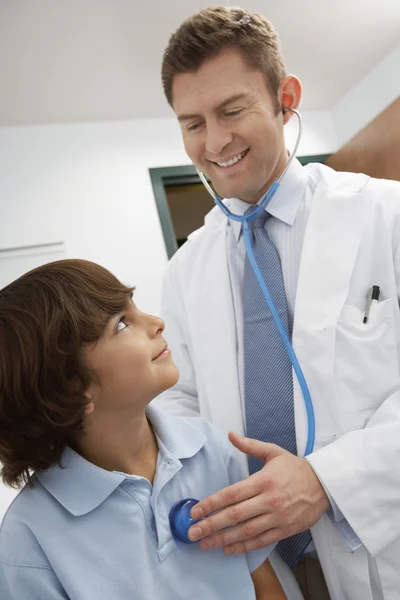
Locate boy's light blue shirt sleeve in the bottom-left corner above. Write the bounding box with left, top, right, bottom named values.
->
left=0, top=562, right=68, bottom=600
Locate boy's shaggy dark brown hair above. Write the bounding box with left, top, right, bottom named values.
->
left=0, top=260, right=133, bottom=487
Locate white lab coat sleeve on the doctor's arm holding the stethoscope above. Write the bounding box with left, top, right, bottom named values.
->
left=307, top=240, right=400, bottom=556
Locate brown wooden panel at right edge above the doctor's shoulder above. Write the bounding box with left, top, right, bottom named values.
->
left=326, top=97, right=400, bottom=181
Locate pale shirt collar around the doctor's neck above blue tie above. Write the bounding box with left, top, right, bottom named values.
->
left=226, top=158, right=308, bottom=240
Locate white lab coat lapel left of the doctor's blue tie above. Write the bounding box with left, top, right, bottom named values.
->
left=193, top=208, right=243, bottom=433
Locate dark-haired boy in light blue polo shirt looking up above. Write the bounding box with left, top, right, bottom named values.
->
left=0, top=260, right=286, bottom=600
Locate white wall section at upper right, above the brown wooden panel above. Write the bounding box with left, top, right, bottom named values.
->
left=332, top=42, right=400, bottom=146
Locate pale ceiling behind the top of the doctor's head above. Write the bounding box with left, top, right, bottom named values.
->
left=0, top=0, right=400, bottom=126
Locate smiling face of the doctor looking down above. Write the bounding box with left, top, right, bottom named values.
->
left=172, top=49, right=288, bottom=203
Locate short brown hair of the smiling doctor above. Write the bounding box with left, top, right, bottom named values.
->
left=161, top=6, right=286, bottom=106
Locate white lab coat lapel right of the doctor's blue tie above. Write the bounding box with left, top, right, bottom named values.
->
left=293, top=182, right=365, bottom=454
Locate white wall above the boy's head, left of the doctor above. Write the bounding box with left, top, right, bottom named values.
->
left=0, top=120, right=191, bottom=310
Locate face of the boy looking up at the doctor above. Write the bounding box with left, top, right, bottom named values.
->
left=84, top=302, right=179, bottom=418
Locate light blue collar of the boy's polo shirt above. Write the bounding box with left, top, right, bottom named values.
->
left=36, top=405, right=206, bottom=516
